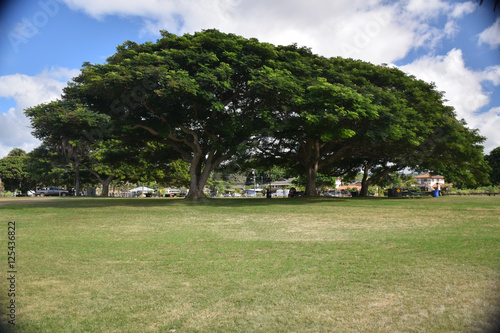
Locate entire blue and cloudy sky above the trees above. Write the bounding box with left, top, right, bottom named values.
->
left=0, top=0, right=500, bottom=158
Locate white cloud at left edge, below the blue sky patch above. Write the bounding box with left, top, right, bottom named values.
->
left=0, top=68, right=79, bottom=158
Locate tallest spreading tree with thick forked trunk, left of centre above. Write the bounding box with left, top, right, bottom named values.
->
left=66, top=30, right=282, bottom=199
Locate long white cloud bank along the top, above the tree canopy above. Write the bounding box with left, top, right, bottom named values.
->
left=56, top=0, right=473, bottom=64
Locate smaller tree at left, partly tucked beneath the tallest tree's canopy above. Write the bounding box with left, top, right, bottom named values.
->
left=26, top=100, right=184, bottom=196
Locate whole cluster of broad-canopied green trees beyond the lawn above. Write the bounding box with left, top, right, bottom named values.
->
left=0, top=30, right=491, bottom=199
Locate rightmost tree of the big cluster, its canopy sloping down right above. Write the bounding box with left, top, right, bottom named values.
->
left=330, top=59, right=487, bottom=196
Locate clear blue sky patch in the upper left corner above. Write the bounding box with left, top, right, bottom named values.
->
left=0, top=1, right=146, bottom=75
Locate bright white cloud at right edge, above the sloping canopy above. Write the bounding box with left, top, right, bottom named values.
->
left=400, top=49, right=500, bottom=151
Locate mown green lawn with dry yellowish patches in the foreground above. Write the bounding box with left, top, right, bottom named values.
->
left=0, top=197, right=500, bottom=332
